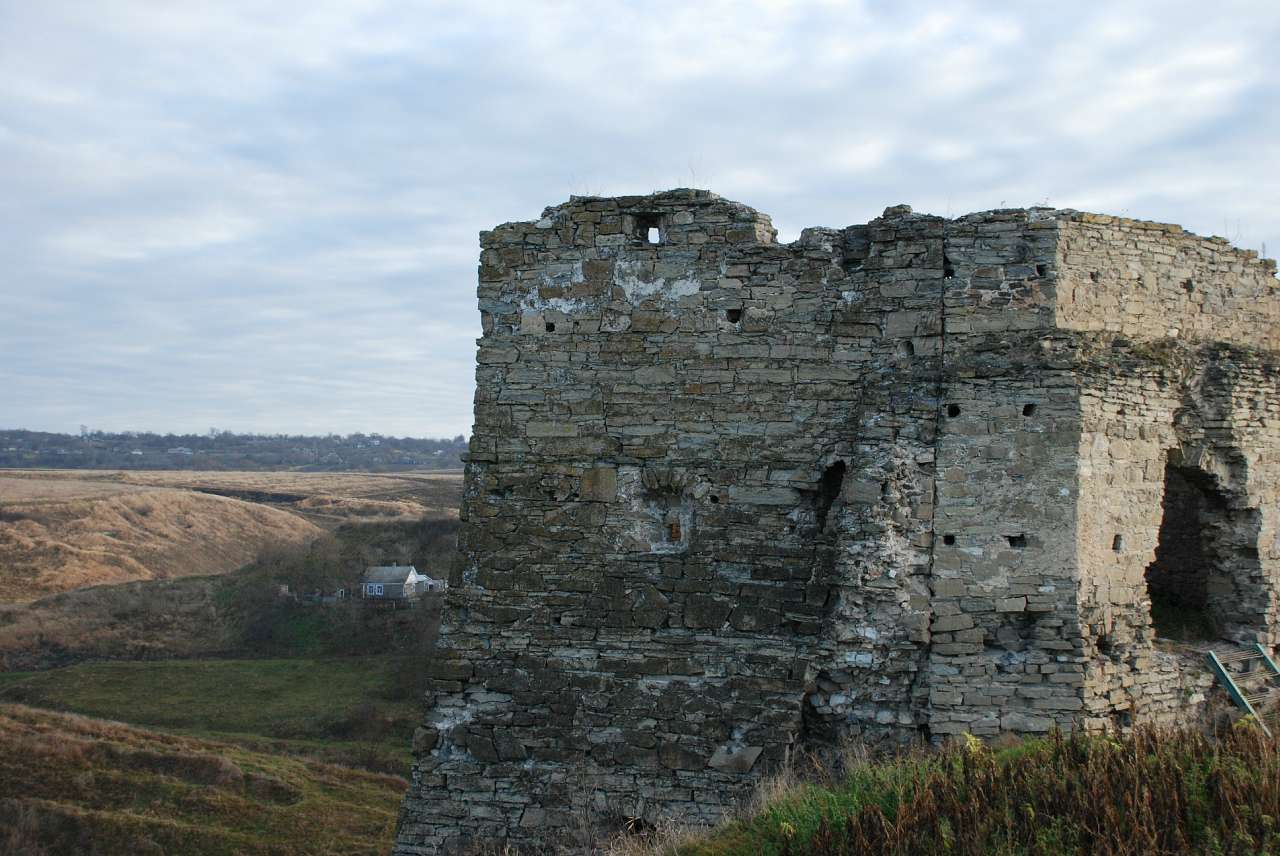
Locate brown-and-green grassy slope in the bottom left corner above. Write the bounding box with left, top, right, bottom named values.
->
left=0, top=705, right=406, bottom=856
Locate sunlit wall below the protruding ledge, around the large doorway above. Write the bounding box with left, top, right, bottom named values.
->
left=1076, top=343, right=1280, bottom=727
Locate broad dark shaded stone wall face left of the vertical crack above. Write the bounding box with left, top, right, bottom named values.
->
left=401, top=192, right=942, bottom=852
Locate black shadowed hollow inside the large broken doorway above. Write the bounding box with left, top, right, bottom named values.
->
left=1146, top=463, right=1225, bottom=641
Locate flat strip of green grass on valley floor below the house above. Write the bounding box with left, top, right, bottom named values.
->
left=0, top=656, right=420, bottom=772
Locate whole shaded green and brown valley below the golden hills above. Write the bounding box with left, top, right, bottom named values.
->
left=0, top=511, right=458, bottom=856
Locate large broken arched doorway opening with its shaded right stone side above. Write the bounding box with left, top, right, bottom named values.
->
left=1146, top=452, right=1270, bottom=642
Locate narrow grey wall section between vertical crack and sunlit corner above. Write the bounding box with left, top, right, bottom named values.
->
left=928, top=210, right=1084, bottom=736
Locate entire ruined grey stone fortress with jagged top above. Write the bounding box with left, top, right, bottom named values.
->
left=396, top=189, right=1280, bottom=853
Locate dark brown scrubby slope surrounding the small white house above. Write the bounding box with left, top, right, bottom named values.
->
left=0, top=511, right=458, bottom=672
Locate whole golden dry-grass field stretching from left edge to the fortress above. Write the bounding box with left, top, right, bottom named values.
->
left=0, top=470, right=462, bottom=603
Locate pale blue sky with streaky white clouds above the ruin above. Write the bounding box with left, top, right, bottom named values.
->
left=0, top=0, right=1280, bottom=436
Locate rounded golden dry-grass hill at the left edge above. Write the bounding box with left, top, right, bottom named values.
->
left=0, top=479, right=321, bottom=603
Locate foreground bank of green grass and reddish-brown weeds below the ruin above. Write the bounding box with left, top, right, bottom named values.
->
left=670, top=723, right=1280, bottom=856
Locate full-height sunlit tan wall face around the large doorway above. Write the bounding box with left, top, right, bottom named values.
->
left=1056, top=212, right=1280, bottom=725
